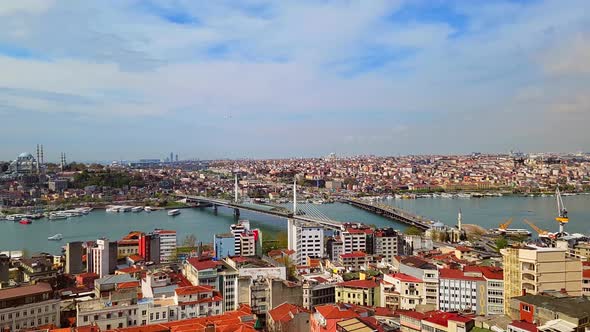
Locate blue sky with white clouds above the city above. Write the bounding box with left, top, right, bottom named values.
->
left=0, top=0, right=590, bottom=161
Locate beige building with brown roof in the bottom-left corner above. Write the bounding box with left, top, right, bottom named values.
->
left=0, top=282, right=60, bottom=332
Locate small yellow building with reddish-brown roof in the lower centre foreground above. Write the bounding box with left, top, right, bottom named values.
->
left=335, top=280, right=380, bottom=307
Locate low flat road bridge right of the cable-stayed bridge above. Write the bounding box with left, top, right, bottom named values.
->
left=342, top=198, right=433, bottom=230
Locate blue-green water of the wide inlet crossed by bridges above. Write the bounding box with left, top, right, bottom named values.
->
left=0, top=195, right=590, bottom=254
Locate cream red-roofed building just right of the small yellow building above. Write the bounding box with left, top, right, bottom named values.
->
left=383, top=273, right=425, bottom=310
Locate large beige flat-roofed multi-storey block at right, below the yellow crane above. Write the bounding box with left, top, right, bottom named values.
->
left=500, top=246, right=582, bottom=313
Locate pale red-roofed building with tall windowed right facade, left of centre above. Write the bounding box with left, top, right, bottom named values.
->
left=182, top=258, right=239, bottom=312
